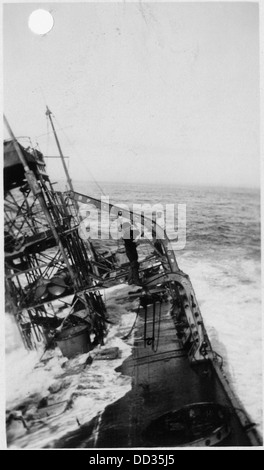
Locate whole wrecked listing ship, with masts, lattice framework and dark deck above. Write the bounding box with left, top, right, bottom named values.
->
left=4, top=109, right=261, bottom=447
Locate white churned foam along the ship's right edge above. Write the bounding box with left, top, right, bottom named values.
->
left=177, top=254, right=262, bottom=432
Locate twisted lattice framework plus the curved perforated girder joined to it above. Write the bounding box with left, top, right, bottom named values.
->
left=4, top=132, right=211, bottom=361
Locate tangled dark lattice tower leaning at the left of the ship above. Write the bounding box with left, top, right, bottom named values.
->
left=4, top=140, right=106, bottom=349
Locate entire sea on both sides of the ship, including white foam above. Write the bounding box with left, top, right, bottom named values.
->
left=6, top=182, right=262, bottom=448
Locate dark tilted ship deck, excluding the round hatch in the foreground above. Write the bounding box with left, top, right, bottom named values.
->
left=56, top=303, right=261, bottom=448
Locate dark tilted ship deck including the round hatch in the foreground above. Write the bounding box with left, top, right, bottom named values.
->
left=55, top=280, right=261, bottom=448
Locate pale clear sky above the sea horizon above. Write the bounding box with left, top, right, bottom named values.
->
left=3, top=2, right=260, bottom=187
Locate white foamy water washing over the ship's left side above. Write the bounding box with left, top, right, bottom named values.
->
left=6, top=286, right=135, bottom=449
